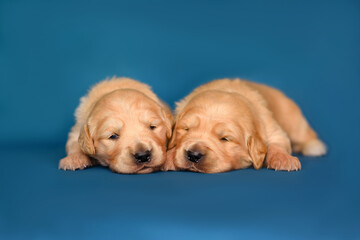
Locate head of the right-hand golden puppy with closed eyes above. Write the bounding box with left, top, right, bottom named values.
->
left=165, top=91, right=266, bottom=173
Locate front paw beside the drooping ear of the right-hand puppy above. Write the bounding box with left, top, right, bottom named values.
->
left=266, top=150, right=301, bottom=171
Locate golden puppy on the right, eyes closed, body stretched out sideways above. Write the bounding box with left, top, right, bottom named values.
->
left=163, top=79, right=326, bottom=173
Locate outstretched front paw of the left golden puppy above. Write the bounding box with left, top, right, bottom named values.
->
left=59, top=153, right=93, bottom=171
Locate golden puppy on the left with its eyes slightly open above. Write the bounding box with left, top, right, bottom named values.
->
left=59, top=78, right=172, bottom=173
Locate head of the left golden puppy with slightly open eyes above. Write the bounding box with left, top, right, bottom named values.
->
left=79, top=89, right=172, bottom=173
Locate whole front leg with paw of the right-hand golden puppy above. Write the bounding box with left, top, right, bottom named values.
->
left=265, top=114, right=301, bottom=171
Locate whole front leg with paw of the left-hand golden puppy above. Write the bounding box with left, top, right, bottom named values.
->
left=59, top=125, right=97, bottom=171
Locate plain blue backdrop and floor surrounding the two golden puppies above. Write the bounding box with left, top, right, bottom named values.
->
left=0, top=0, right=360, bottom=239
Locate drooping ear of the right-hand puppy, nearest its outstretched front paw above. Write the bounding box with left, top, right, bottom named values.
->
left=247, top=134, right=266, bottom=169
